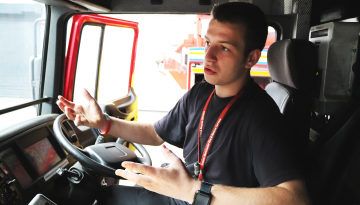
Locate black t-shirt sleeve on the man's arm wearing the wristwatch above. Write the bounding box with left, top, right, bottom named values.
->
left=249, top=107, right=303, bottom=187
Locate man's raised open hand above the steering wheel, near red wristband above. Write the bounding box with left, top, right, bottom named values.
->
left=56, top=89, right=106, bottom=130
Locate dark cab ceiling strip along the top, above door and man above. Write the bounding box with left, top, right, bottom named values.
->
left=36, top=0, right=286, bottom=15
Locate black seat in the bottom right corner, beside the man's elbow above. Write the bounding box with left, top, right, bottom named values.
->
left=307, top=103, right=360, bottom=205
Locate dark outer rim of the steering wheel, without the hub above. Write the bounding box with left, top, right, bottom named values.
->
left=53, top=114, right=150, bottom=178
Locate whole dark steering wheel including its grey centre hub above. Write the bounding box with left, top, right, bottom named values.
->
left=53, top=114, right=151, bottom=178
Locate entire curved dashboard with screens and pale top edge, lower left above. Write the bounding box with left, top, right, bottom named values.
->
left=0, top=114, right=94, bottom=205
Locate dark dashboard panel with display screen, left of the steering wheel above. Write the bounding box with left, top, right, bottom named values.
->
left=0, top=127, right=67, bottom=189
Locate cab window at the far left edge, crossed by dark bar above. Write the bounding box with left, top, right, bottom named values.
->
left=0, top=0, right=46, bottom=129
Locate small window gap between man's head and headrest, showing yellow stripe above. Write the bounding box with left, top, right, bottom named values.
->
left=250, top=26, right=277, bottom=88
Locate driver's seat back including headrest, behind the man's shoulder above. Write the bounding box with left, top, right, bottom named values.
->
left=265, top=39, right=317, bottom=149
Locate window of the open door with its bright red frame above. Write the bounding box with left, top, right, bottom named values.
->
left=64, top=15, right=137, bottom=103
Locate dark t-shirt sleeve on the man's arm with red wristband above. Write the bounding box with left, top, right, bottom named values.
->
left=154, top=89, right=189, bottom=148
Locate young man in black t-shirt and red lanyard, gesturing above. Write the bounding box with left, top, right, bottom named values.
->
left=58, top=2, right=308, bottom=205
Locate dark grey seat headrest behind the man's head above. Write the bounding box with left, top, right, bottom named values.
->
left=267, top=39, right=317, bottom=90
